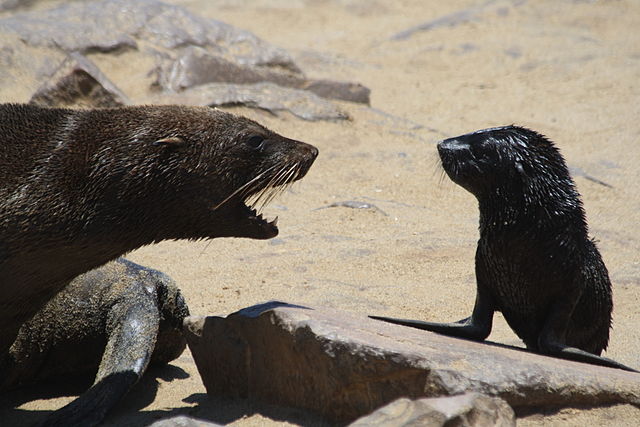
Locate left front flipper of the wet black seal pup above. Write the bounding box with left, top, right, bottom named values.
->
left=369, top=287, right=494, bottom=341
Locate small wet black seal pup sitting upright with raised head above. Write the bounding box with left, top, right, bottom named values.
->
left=372, top=126, right=633, bottom=371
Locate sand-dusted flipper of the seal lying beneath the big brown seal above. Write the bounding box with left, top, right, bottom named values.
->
left=43, top=266, right=160, bottom=426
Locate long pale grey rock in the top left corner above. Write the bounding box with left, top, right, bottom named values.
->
left=0, top=0, right=292, bottom=67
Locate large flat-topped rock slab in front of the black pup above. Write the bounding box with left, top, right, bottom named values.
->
left=185, top=302, right=640, bottom=423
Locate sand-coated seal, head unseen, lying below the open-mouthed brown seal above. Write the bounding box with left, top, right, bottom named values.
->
left=0, top=258, right=189, bottom=426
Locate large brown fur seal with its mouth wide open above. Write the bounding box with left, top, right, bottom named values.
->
left=0, top=104, right=318, bottom=355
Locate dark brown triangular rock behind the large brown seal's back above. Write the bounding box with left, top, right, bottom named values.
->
left=29, top=53, right=130, bottom=107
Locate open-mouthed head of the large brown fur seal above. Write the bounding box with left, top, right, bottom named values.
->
left=131, top=107, right=318, bottom=239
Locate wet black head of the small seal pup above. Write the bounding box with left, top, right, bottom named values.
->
left=438, top=126, right=578, bottom=211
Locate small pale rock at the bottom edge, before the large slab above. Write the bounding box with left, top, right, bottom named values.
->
left=349, top=393, right=516, bottom=427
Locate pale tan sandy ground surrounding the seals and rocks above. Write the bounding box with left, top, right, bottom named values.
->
left=5, top=0, right=640, bottom=426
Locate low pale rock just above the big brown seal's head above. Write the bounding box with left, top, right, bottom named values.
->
left=148, top=83, right=348, bottom=121
